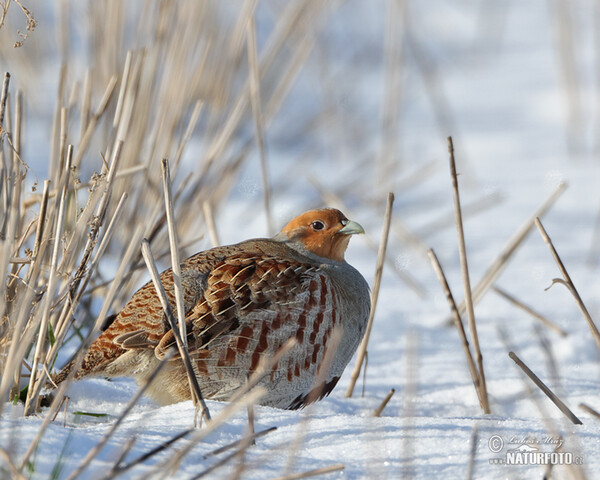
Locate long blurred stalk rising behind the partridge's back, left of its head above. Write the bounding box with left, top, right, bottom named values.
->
left=247, top=8, right=275, bottom=236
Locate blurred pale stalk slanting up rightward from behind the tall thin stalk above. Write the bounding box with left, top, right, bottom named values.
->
left=458, top=183, right=567, bottom=315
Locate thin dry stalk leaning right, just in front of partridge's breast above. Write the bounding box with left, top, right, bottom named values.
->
left=346, top=192, right=394, bottom=398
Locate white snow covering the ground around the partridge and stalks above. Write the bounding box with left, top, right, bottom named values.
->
left=0, top=1, right=600, bottom=479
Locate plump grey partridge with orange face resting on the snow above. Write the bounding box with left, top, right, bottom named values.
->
left=54, top=208, right=370, bottom=409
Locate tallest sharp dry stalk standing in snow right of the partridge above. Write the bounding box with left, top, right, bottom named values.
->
left=448, top=137, right=490, bottom=413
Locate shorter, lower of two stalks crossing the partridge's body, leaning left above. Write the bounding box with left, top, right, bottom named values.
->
left=142, top=239, right=210, bottom=422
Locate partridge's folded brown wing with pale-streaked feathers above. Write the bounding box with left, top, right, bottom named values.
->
left=155, top=252, right=324, bottom=358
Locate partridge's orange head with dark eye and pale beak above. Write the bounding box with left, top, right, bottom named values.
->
left=276, top=208, right=365, bottom=262
